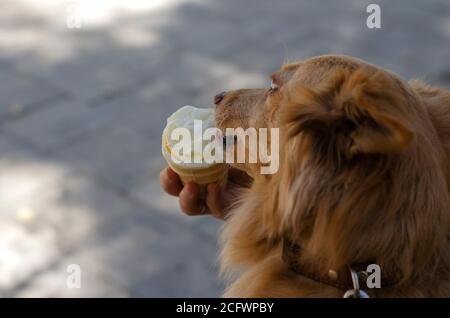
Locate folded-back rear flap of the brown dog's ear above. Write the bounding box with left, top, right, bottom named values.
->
left=340, top=69, right=414, bottom=155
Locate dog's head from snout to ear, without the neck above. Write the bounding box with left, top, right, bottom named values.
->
left=215, top=56, right=417, bottom=174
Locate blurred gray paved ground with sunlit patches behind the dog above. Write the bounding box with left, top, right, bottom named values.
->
left=0, top=0, right=450, bottom=297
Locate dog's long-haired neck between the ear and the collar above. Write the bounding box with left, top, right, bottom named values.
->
left=272, top=149, right=448, bottom=286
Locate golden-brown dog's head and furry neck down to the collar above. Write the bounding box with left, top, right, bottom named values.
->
left=216, top=56, right=449, bottom=284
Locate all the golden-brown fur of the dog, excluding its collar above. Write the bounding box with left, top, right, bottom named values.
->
left=216, top=55, right=450, bottom=297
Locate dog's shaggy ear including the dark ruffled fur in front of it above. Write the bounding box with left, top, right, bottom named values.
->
left=282, top=68, right=414, bottom=157
